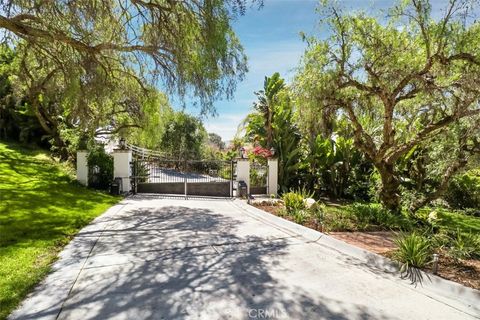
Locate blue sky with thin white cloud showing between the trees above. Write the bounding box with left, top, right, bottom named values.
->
left=179, top=0, right=446, bottom=140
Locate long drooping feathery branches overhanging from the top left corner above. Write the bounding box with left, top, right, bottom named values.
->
left=0, top=0, right=258, bottom=108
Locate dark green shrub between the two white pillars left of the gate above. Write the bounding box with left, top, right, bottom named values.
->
left=87, top=145, right=113, bottom=190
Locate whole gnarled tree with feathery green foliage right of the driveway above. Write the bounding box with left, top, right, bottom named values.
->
left=295, top=0, right=480, bottom=210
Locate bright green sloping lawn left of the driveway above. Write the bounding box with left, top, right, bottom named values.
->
left=0, top=142, right=119, bottom=319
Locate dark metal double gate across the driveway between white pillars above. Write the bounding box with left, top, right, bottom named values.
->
left=131, top=154, right=235, bottom=197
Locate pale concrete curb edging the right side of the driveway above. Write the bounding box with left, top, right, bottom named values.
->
left=233, top=199, right=480, bottom=319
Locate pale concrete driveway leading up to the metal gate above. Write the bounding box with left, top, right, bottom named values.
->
left=11, top=196, right=480, bottom=320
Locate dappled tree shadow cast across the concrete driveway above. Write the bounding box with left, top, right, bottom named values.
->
left=15, top=202, right=390, bottom=320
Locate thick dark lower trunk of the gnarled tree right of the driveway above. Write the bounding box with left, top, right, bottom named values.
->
left=375, top=163, right=401, bottom=212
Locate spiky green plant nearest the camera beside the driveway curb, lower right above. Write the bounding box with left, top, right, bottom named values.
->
left=394, top=232, right=432, bottom=272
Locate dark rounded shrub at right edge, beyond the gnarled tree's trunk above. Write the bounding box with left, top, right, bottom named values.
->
left=444, top=169, right=480, bottom=209
